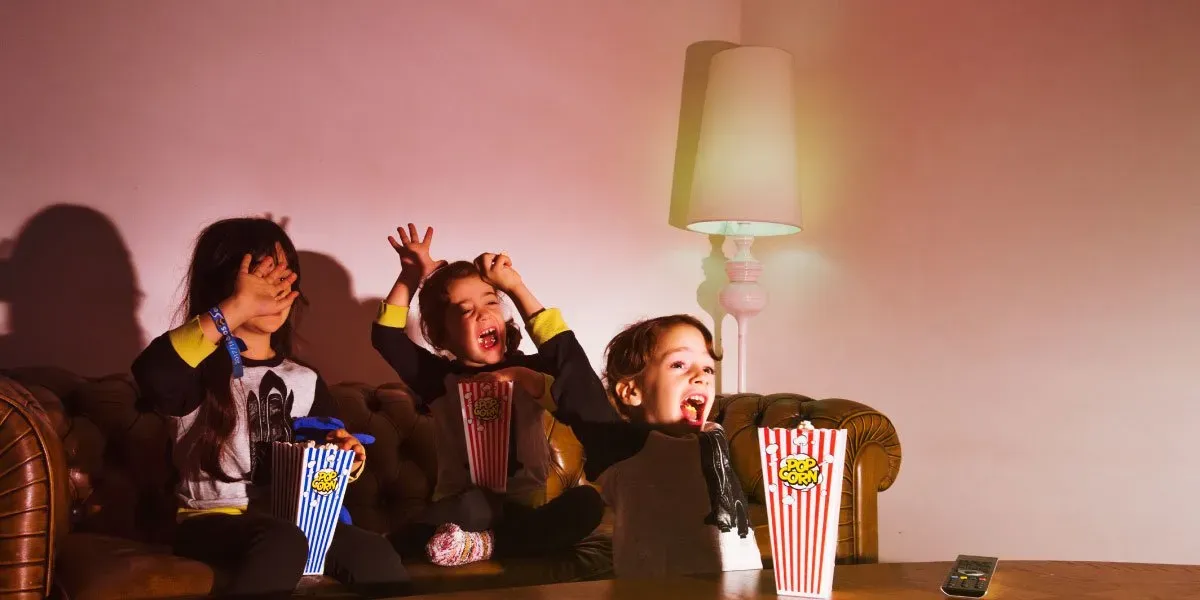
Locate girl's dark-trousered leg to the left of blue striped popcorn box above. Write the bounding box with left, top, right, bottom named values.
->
left=174, top=514, right=308, bottom=598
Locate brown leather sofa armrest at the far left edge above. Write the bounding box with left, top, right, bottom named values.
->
left=0, top=376, right=71, bottom=599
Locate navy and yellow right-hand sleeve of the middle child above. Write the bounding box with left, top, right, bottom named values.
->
left=527, top=308, right=620, bottom=428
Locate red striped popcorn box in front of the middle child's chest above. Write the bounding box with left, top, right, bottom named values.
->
left=458, top=379, right=512, bottom=493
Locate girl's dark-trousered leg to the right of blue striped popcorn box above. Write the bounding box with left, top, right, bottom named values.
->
left=325, top=523, right=408, bottom=596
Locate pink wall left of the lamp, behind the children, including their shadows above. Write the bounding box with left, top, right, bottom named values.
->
left=0, top=0, right=739, bottom=382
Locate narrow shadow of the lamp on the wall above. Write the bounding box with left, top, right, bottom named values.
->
left=667, top=41, right=738, bottom=391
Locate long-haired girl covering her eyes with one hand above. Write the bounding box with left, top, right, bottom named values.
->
left=132, top=218, right=408, bottom=598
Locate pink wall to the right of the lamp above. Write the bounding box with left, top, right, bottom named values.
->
left=742, top=0, right=1200, bottom=563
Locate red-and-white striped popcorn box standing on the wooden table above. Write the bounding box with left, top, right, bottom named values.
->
left=758, top=424, right=846, bottom=599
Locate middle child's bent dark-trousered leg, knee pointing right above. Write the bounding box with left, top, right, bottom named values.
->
left=496, top=486, right=605, bottom=557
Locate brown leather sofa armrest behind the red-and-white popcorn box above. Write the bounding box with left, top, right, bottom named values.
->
left=712, top=394, right=900, bottom=564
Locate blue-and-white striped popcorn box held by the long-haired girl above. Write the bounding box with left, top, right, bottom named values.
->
left=271, top=442, right=354, bottom=575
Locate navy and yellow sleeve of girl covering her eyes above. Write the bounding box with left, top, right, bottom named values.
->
left=130, top=318, right=217, bottom=416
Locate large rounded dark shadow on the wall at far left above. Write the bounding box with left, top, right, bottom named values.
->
left=0, top=204, right=145, bottom=376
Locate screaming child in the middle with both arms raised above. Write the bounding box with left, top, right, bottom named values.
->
left=371, top=223, right=616, bottom=566
